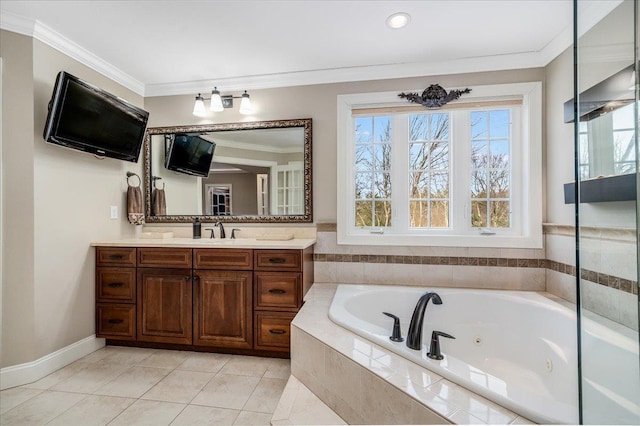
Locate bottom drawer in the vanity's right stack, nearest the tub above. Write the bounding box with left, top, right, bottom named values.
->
left=254, top=312, right=296, bottom=352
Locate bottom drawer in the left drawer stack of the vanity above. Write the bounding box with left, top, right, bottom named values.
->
left=96, top=303, right=136, bottom=340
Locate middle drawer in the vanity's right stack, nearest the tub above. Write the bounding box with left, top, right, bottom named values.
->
left=254, top=272, right=302, bottom=311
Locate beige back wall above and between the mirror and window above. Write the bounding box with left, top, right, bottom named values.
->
left=145, top=68, right=544, bottom=223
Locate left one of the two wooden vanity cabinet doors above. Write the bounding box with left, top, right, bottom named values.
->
left=137, top=268, right=193, bottom=344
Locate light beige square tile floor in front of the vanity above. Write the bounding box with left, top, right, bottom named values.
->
left=0, top=346, right=291, bottom=426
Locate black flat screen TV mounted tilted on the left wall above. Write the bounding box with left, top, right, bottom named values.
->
left=44, top=71, right=149, bottom=163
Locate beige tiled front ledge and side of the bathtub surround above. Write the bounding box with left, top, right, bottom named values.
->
left=291, top=283, right=531, bottom=424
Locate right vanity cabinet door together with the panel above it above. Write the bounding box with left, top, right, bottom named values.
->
left=193, top=249, right=253, bottom=349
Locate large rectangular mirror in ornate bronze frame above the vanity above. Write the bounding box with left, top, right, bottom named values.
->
left=145, top=119, right=311, bottom=222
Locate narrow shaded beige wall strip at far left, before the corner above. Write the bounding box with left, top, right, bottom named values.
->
left=0, top=31, right=36, bottom=366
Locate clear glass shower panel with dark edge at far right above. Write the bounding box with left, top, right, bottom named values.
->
left=574, top=0, right=640, bottom=425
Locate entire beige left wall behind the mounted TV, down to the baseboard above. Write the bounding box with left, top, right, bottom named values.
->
left=1, top=31, right=143, bottom=366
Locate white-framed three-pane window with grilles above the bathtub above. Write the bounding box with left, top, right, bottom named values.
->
left=338, top=83, right=542, bottom=248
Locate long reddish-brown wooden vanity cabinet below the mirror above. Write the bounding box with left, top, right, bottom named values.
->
left=96, top=243, right=313, bottom=357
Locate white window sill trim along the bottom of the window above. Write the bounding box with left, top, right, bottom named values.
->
left=337, top=233, right=542, bottom=249
